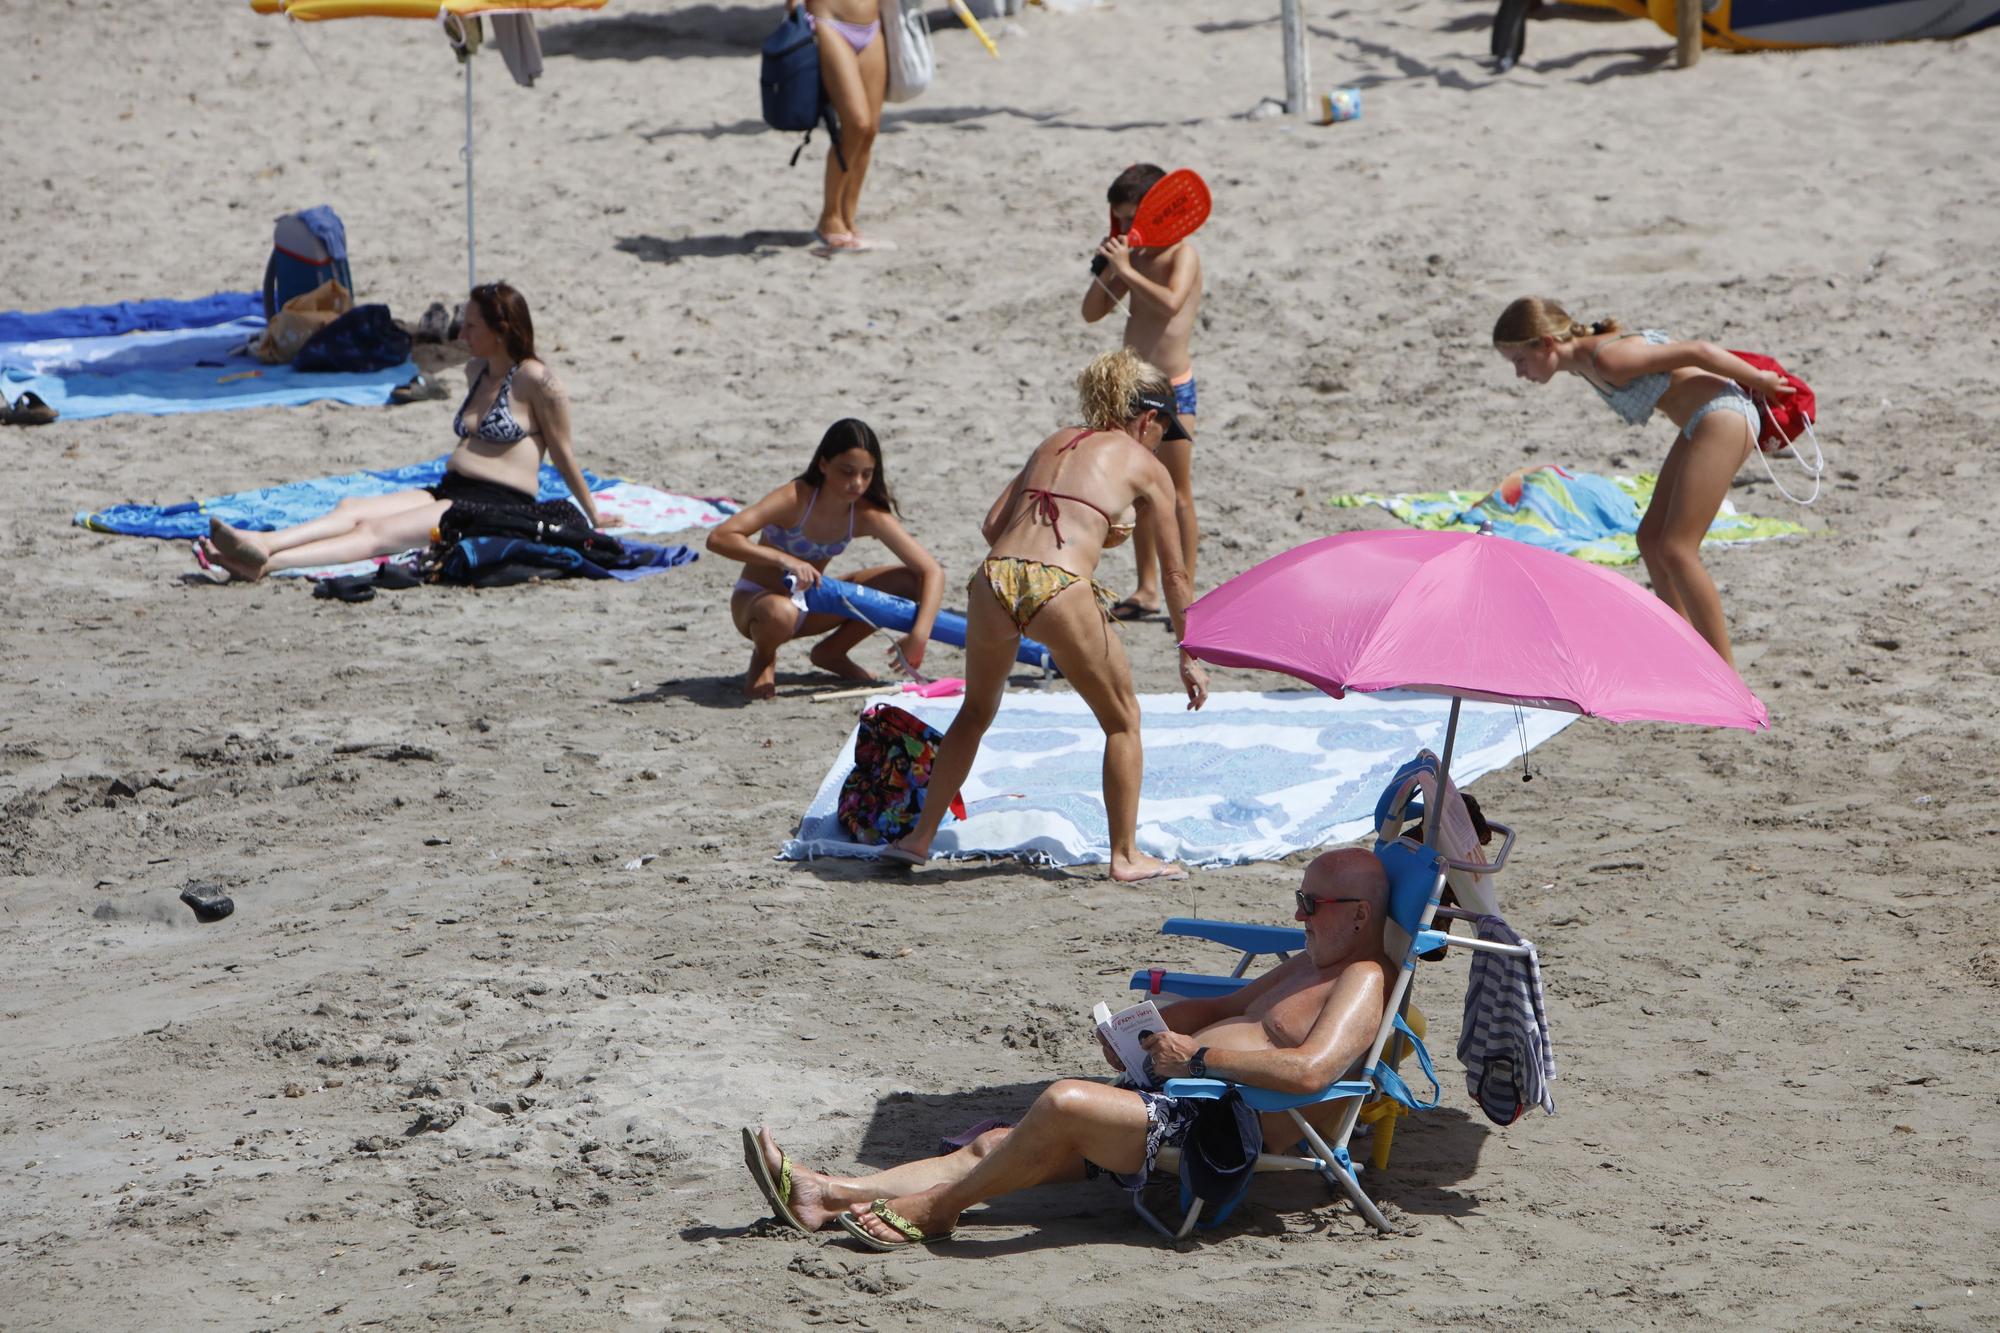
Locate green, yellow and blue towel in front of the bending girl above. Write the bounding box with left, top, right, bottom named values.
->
left=1328, top=466, right=1806, bottom=564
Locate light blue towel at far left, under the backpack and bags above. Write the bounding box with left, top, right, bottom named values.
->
left=0, top=314, right=416, bottom=420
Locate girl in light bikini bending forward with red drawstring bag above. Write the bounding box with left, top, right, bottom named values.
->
left=1494, top=296, right=1792, bottom=667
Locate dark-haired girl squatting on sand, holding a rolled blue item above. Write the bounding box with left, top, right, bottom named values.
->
left=708, top=416, right=944, bottom=699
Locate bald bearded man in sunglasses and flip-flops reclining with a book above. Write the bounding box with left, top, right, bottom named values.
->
left=744, top=849, right=1394, bottom=1249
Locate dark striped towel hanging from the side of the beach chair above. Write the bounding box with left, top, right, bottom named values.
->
left=1458, top=917, right=1556, bottom=1125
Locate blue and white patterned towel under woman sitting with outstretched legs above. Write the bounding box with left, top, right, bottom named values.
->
left=74, top=454, right=740, bottom=578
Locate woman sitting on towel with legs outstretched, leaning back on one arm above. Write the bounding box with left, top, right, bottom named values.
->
left=194, top=282, right=598, bottom=582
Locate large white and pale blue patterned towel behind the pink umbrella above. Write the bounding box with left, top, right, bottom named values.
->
left=782, top=691, right=1576, bottom=865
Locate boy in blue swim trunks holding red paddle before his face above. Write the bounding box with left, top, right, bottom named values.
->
left=1084, top=162, right=1208, bottom=620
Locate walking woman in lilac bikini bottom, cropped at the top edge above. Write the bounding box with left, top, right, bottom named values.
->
left=784, top=0, right=896, bottom=256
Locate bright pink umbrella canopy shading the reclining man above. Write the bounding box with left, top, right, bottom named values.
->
left=1184, top=530, right=1770, bottom=731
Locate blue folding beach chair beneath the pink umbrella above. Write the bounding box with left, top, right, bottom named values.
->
left=1132, top=751, right=1532, bottom=1239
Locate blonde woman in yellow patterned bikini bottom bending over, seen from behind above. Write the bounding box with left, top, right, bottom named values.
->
left=884, top=348, right=1208, bottom=883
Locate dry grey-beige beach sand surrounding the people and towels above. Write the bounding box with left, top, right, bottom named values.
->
left=0, top=0, right=2000, bottom=1329
